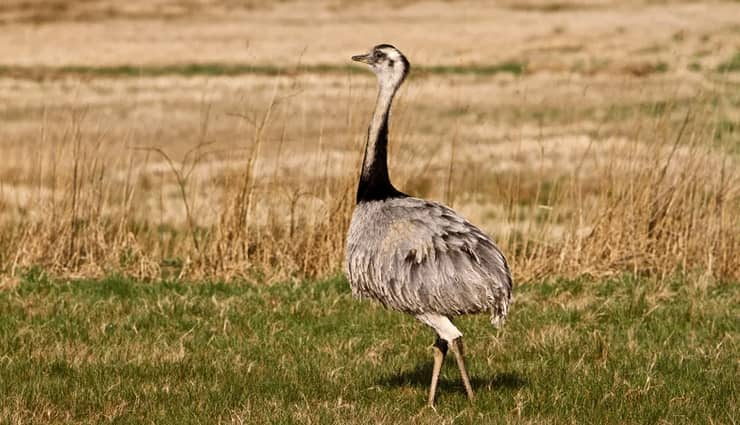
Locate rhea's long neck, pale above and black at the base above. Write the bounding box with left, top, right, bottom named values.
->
left=357, top=85, right=405, bottom=204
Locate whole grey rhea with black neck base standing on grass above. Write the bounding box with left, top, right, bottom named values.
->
left=345, top=44, right=512, bottom=406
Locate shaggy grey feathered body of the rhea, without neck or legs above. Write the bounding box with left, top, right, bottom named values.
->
left=346, top=197, right=511, bottom=326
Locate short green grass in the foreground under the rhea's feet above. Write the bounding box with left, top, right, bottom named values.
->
left=0, top=274, right=740, bottom=424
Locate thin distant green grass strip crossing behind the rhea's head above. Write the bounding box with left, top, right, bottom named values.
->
left=0, top=58, right=525, bottom=80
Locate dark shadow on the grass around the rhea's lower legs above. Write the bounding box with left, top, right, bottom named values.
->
left=377, top=362, right=527, bottom=392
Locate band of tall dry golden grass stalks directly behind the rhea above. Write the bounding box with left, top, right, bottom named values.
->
left=0, top=74, right=740, bottom=281
